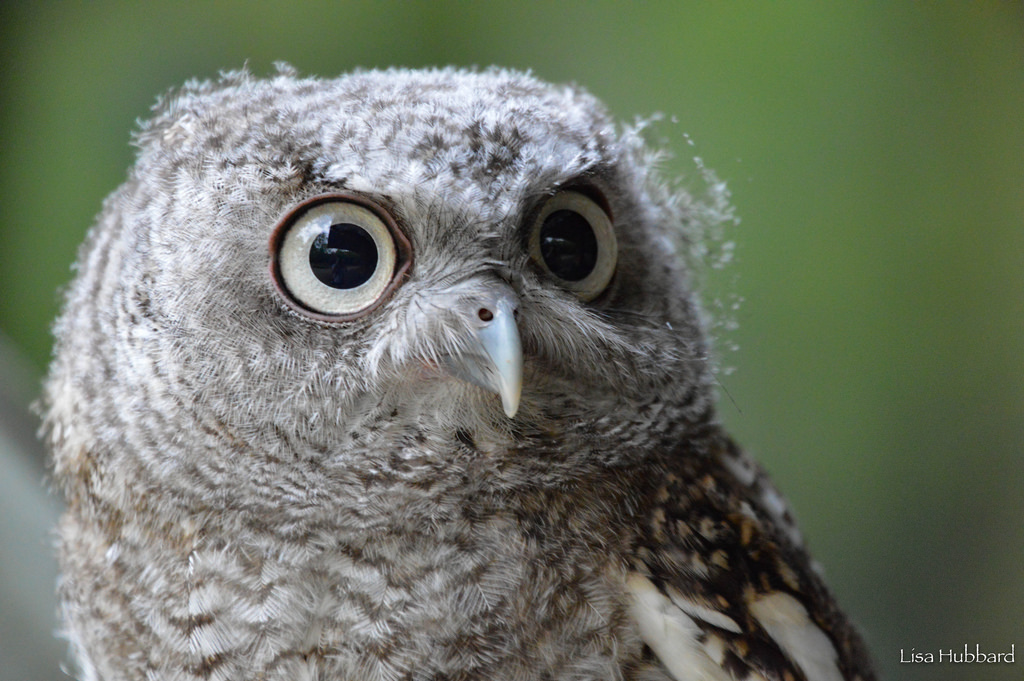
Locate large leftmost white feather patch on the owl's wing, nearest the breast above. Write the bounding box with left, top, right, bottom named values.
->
left=626, top=572, right=764, bottom=681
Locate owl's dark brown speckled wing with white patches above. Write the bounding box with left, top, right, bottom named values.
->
left=626, top=426, right=874, bottom=681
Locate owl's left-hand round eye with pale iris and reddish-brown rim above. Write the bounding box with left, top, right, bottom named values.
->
left=270, top=195, right=411, bottom=322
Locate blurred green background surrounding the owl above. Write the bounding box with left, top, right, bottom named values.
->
left=0, top=0, right=1024, bottom=681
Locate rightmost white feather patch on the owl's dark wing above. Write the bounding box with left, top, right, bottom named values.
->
left=750, top=592, right=843, bottom=681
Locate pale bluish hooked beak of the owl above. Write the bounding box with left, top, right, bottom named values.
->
left=446, top=288, right=522, bottom=418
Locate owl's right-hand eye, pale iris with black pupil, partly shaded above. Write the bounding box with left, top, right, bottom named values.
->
left=529, top=191, right=618, bottom=301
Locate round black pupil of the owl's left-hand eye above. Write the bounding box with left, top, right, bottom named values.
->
left=309, top=222, right=377, bottom=289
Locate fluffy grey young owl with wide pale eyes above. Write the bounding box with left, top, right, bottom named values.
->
left=44, top=67, right=874, bottom=681
